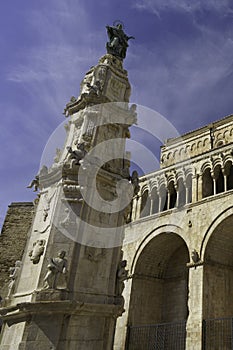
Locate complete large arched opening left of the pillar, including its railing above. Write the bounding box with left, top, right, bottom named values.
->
left=128, top=232, right=189, bottom=350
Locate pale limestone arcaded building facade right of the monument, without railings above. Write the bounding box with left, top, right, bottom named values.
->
left=114, top=115, right=233, bottom=350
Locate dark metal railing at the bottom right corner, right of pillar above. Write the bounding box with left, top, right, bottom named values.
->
left=203, top=317, right=233, bottom=350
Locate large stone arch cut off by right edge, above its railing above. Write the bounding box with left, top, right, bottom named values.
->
left=201, top=211, right=233, bottom=319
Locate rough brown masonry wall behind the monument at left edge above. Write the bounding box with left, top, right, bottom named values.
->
left=0, top=202, right=34, bottom=290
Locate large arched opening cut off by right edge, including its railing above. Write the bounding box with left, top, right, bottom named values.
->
left=203, top=215, right=233, bottom=350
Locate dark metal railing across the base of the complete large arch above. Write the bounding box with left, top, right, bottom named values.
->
left=126, top=321, right=186, bottom=350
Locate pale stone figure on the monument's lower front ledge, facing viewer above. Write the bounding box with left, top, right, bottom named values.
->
left=44, top=250, right=67, bottom=289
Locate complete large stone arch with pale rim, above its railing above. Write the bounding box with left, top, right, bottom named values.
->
left=128, top=226, right=189, bottom=326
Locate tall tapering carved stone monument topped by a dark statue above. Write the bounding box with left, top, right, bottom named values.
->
left=0, top=25, right=136, bottom=350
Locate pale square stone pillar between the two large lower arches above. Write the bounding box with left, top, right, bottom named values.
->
left=186, top=262, right=203, bottom=350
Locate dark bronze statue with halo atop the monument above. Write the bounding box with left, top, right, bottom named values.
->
left=106, top=23, right=135, bottom=60
